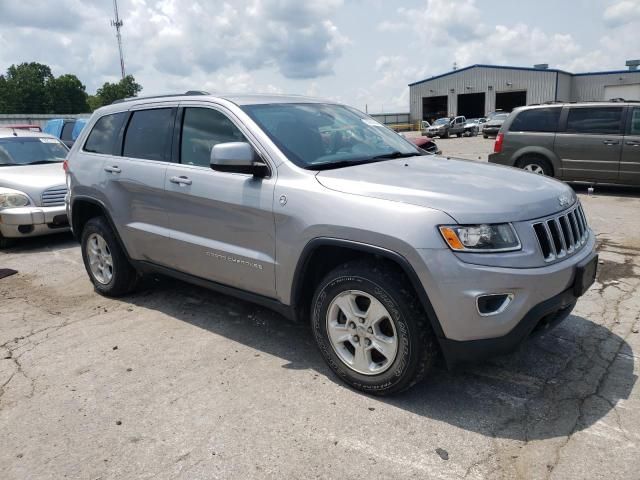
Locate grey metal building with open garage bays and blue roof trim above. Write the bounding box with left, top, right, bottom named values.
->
left=409, top=61, right=640, bottom=123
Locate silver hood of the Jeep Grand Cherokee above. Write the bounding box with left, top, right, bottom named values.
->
left=316, top=155, right=576, bottom=224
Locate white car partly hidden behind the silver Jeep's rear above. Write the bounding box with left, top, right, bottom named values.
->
left=0, top=128, right=69, bottom=248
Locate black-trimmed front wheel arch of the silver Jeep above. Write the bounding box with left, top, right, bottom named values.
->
left=291, top=237, right=444, bottom=339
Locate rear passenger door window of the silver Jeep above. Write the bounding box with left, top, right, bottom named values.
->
left=122, top=108, right=174, bottom=161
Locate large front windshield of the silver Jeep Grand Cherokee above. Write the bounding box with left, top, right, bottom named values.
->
left=243, top=103, right=421, bottom=170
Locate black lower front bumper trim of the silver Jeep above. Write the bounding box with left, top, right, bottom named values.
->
left=440, top=288, right=577, bottom=368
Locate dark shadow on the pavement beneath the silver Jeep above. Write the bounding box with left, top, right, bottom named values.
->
left=125, top=277, right=636, bottom=441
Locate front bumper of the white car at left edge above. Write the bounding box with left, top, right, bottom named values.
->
left=0, top=205, right=69, bottom=238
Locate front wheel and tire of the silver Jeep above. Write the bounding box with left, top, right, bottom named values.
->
left=311, top=261, right=439, bottom=396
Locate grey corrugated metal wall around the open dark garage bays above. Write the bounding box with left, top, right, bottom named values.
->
left=416, top=67, right=556, bottom=122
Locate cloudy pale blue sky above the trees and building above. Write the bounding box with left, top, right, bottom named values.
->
left=0, top=0, right=640, bottom=113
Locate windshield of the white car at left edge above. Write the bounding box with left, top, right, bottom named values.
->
left=0, top=137, right=69, bottom=166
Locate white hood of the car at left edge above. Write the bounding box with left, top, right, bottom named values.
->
left=0, top=162, right=66, bottom=205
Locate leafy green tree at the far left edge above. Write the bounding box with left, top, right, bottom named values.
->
left=0, top=62, right=53, bottom=113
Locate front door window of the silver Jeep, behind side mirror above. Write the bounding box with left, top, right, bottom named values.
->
left=180, top=108, right=246, bottom=167
